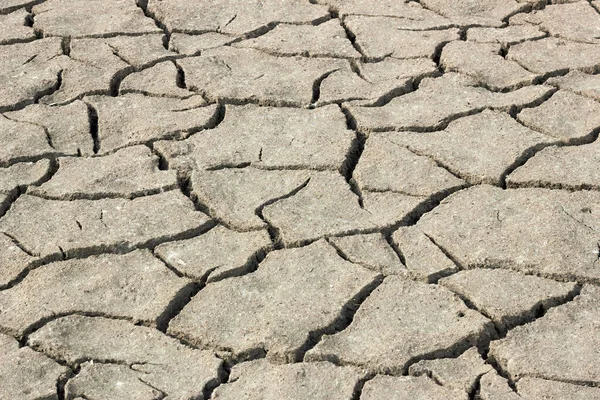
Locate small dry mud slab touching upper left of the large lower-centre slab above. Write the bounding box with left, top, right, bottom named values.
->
left=154, top=226, right=272, bottom=282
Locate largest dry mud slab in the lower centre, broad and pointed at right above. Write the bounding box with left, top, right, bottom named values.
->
left=169, top=241, right=378, bottom=362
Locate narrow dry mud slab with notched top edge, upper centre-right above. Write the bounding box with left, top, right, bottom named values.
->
left=317, top=58, right=437, bottom=105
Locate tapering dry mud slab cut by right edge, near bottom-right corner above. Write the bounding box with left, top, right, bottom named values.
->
left=489, top=286, right=600, bottom=386
